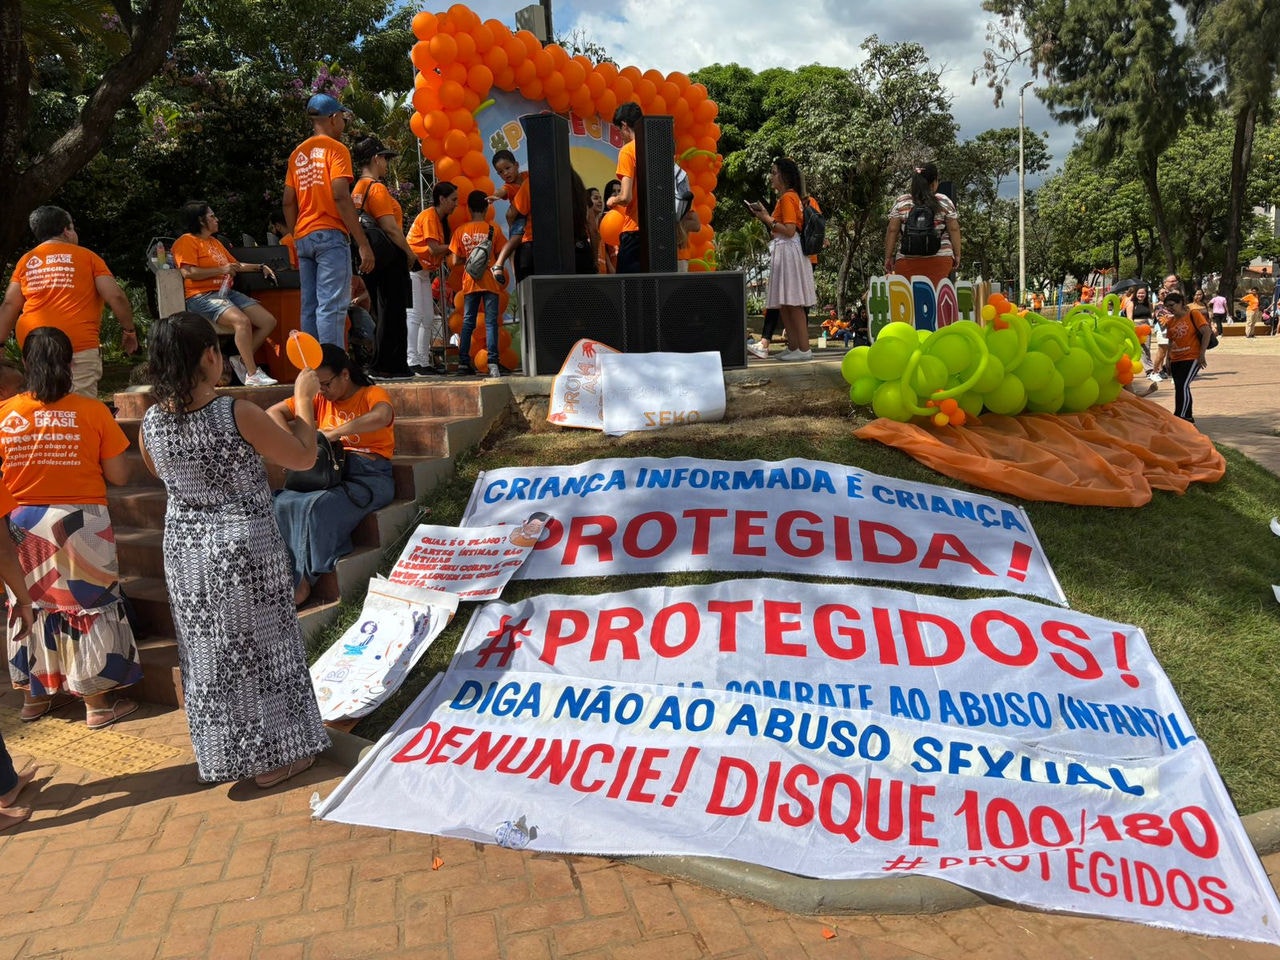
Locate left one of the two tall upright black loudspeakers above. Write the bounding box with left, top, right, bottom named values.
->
left=520, top=114, right=573, bottom=274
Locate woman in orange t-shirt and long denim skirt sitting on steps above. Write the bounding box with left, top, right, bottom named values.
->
left=266, top=343, right=396, bottom=607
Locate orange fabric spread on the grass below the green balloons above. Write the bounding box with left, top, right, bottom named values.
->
left=854, top=392, right=1226, bottom=507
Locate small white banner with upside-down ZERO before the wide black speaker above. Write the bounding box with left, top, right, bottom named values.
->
left=600, top=351, right=724, bottom=436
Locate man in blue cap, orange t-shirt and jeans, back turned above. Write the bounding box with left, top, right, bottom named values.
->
left=284, top=93, right=374, bottom=349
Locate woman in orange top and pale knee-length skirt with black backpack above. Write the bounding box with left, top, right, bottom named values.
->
left=746, top=156, right=818, bottom=360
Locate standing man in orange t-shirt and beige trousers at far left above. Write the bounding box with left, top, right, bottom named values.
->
left=0, top=206, right=138, bottom=399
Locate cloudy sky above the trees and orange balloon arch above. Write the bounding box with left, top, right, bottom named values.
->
left=409, top=0, right=1075, bottom=186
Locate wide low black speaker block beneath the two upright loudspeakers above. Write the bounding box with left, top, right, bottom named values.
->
left=520, top=272, right=746, bottom=376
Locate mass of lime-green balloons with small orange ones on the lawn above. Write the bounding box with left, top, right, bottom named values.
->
left=841, top=294, right=1142, bottom=426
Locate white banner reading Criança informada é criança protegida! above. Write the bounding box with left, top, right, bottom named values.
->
left=462, top=457, right=1066, bottom=604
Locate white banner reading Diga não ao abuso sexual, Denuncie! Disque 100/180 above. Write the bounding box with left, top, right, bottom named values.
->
left=317, top=668, right=1280, bottom=942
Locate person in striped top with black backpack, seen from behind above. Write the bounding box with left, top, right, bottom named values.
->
left=884, top=163, right=960, bottom=285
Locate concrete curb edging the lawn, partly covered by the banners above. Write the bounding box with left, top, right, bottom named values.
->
left=324, top=730, right=1280, bottom=916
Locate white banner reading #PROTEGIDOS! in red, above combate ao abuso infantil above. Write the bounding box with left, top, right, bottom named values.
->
left=453, top=580, right=1197, bottom=756
